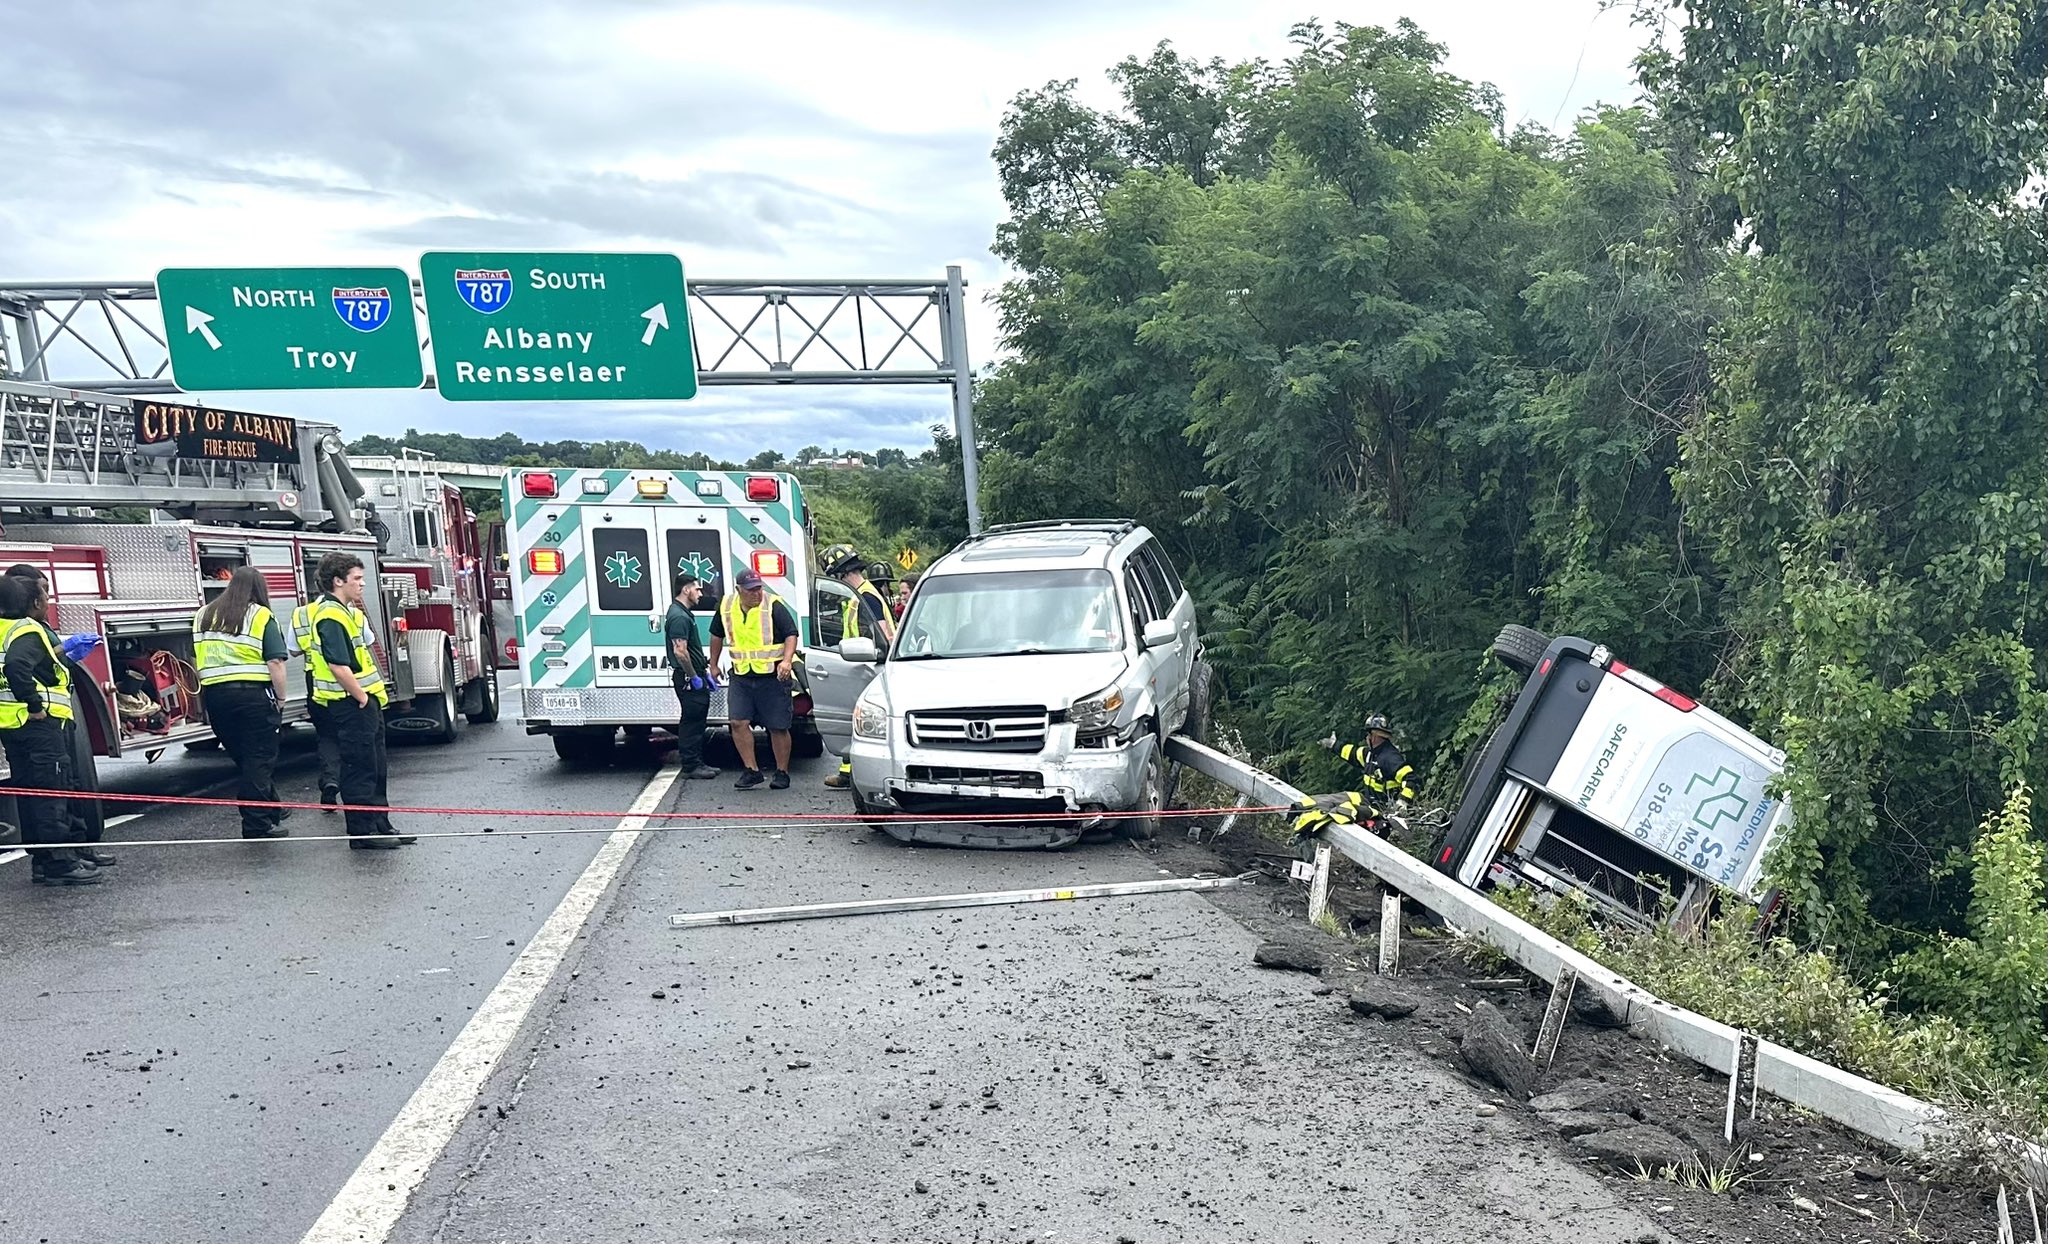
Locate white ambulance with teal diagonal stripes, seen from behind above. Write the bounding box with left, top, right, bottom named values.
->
left=504, top=469, right=844, bottom=764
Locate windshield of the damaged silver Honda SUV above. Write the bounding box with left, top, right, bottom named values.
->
left=891, top=570, right=1124, bottom=660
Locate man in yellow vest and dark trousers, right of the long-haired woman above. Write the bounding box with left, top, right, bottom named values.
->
left=305, top=553, right=414, bottom=851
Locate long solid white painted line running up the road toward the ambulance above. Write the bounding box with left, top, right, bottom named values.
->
left=301, top=764, right=682, bottom=1244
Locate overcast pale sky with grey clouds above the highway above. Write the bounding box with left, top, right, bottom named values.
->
left=0, top=0, right=1640, bottom=457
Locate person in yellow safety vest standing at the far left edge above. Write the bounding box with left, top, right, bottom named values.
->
left=0, top=574, right=106, bottom=885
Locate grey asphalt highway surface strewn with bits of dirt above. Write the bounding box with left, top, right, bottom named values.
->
left=0, top=721, right=1657, bottom=1244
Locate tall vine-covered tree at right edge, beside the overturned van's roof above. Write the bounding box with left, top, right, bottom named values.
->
left=1647, top=0, right=2048, bottom=951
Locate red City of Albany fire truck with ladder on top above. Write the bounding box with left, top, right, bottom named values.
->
left=0, top=381, right=498, bottom=848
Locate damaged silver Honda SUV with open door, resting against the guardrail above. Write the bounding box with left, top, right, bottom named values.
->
left=805, top=521, right=1208, bottom=846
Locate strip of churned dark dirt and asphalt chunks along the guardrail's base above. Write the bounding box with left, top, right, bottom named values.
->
left=1143, top=822, right=2028, bottom=1244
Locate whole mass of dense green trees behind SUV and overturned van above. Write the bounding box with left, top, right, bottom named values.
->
left=979, top=0, right=2048, bottom=1066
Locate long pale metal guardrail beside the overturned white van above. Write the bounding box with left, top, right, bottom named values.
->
left=1167, top=736, right=1957, bottom=1164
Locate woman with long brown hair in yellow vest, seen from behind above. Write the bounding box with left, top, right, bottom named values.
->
left=193, top=566, right=291, bottom=838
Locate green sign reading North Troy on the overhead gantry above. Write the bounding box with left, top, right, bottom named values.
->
left=156, top=268, right=424, bottom=391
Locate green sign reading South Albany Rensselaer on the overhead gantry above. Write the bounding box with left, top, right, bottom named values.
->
left=420, top=250, right=696, bottom=402
